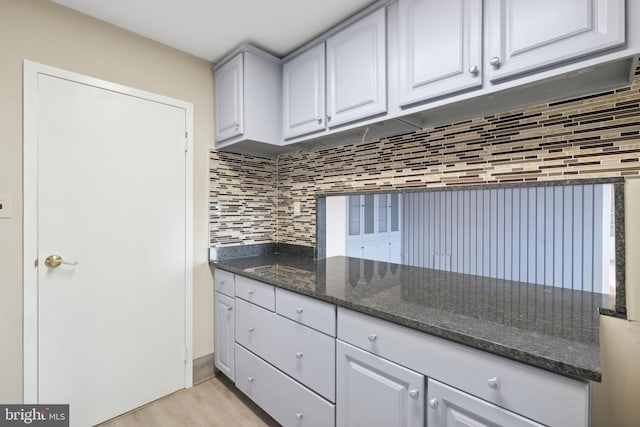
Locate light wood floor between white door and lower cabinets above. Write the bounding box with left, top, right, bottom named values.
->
left=99, top=375, right=279, bottom=427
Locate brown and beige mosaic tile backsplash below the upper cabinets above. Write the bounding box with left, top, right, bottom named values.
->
left=210, top=66, right=640, bottom=251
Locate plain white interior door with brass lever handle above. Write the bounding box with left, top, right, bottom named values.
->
left=25, top=64, right=190, bottom=426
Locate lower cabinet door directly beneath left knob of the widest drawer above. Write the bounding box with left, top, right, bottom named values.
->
left=336, top=341, right=424, bottom=427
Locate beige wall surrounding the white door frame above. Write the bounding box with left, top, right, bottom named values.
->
left=0, top=0, right=213, bottom=403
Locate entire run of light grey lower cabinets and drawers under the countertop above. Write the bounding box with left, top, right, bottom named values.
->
left=214, top=275, right=590, bottom=427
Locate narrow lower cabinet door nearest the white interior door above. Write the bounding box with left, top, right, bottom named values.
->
left=213, top=292, right=235, bottom=381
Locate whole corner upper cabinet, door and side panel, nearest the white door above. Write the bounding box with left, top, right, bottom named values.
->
left=213, top=44, right=282, bottom=148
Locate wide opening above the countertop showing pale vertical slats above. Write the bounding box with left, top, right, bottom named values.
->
left=326, top=184, right=616, bottom=295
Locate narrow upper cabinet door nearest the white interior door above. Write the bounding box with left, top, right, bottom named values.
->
left=214, top=53, right=244, bottom=142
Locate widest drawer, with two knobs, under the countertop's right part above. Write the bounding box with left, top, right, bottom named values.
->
left=338, top=307, right=589, bottom=427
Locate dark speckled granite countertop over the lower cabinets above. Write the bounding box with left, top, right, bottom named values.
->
left=211, top=254, right=610, bottom=381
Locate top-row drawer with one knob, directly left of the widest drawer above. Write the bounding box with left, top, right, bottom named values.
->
left=276, top=288, right=336, bottom=337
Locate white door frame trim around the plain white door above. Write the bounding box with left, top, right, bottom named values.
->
left=22, top=60, right=194, bottom=403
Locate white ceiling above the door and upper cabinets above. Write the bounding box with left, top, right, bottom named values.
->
left=53, top=0, right=375, bottom=62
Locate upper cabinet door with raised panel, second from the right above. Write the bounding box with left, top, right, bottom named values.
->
left=399, top=0, right=482, bottom=106
